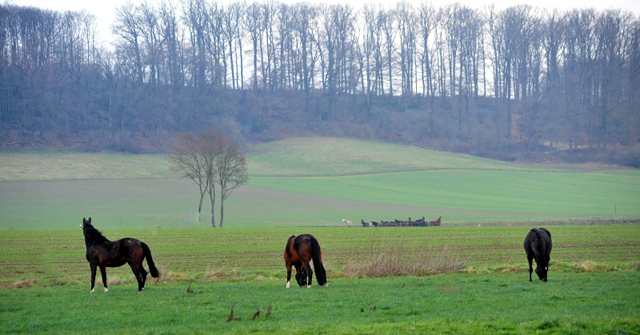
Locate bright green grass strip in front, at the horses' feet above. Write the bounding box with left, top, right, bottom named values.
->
left=0, top=272, right=640, bottom=334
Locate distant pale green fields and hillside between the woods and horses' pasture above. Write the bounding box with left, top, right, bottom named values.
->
left=0, top=138, right=640, bottom=229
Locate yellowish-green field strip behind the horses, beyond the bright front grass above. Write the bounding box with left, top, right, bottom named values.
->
left=0, top=226, right=640, bottom=286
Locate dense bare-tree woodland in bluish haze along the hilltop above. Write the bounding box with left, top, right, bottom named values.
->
left=0, top=0, right=640, bottom=167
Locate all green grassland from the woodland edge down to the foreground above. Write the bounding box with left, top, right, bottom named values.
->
left=0, top=138, right=640, bottom=334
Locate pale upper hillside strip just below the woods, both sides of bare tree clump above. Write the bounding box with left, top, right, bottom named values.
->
left=0, top=136, right=633, bottom=181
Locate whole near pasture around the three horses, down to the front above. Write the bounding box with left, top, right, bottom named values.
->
left=0, top=227, right=640, bottom=334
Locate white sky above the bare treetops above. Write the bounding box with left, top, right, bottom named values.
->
left=4, top=0, right=640, bottom=46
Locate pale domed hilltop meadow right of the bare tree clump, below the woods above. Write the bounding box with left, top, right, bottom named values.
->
left=248, top=137, right=555, bottom=176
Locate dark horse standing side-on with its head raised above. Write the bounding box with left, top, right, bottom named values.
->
left=82, top=218, right=159, bottom=293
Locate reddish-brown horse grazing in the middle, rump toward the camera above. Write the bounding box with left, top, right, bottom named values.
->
left=284, top=234, right=329, bottom=288
